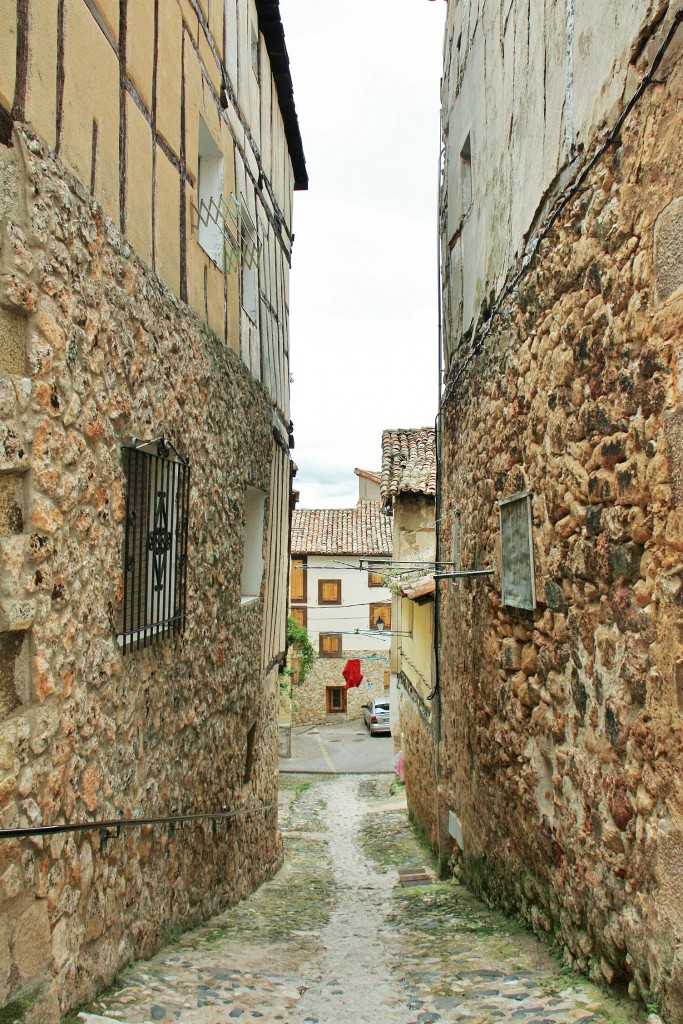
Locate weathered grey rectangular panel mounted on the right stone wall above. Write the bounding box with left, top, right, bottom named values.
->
left=498, top=490, right=536, bottom=611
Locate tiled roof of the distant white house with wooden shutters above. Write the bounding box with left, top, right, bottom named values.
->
left=292, top=502, right=392, bottom=555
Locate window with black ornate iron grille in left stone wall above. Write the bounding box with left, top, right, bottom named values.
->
left=118, top=436, right=189, bottom=653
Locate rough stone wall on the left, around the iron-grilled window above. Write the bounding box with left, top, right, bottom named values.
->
left=0, top=129, right=281, bottom=1024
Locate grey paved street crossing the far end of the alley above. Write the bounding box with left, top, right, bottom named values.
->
left=280, top=721, right=393, bottom=775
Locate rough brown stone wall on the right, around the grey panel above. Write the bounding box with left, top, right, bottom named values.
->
left=440, top=46, right=683, bottom=1024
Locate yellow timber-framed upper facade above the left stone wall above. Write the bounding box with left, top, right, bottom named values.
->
left=0, top=0, right=307, bottom=415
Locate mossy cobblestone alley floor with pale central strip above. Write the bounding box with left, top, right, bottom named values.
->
left=80, top=776, right=641, bottom=1024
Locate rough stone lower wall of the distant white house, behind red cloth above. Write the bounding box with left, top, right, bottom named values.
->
left=292, top=651, right=389, bottom=725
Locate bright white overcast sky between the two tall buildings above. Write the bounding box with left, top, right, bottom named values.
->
left=280, top=0, right=446, bottom=508
